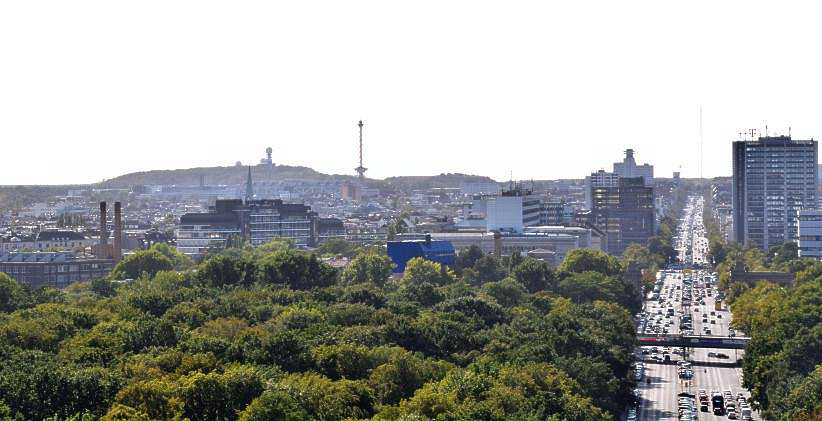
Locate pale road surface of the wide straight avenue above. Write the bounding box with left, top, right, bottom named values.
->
left=629, top=197, right=761, bottom=421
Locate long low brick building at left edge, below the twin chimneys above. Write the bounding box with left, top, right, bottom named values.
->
left=0, top=252, right=114, bottom=288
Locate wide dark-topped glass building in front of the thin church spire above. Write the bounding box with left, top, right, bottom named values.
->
left=177, top=199, right=318, bottom=260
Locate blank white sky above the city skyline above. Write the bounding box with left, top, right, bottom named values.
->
left=0, top=0, right=822, bottom=184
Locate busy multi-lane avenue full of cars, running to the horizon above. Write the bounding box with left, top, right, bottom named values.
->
left=627, top=196, right=757, bottom=421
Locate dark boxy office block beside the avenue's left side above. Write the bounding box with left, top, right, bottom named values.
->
left=591, top=177, right=654, bottom=255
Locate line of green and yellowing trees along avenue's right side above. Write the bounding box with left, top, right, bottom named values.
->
left=704, top=189, right=822, bottom=421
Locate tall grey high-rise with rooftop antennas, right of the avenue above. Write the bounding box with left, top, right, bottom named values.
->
left=732, top=136, right=818, bottom=250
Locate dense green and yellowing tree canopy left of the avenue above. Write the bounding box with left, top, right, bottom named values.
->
left=0, top=243, right=644, bottom=421
